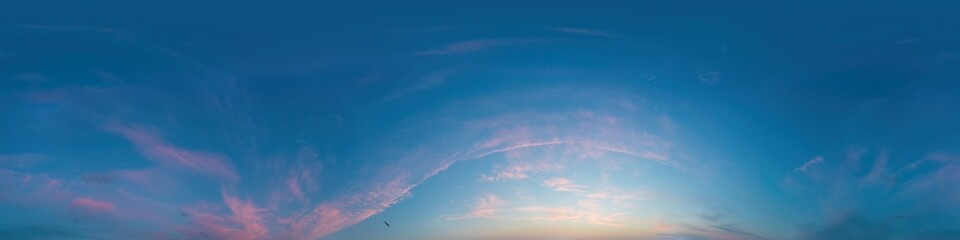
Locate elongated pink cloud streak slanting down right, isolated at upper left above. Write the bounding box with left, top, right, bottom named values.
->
left=106, top=125, right=239, bottom=182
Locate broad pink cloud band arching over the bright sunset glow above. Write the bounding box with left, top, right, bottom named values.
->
left=284, top=87, right=687, bottom=238
